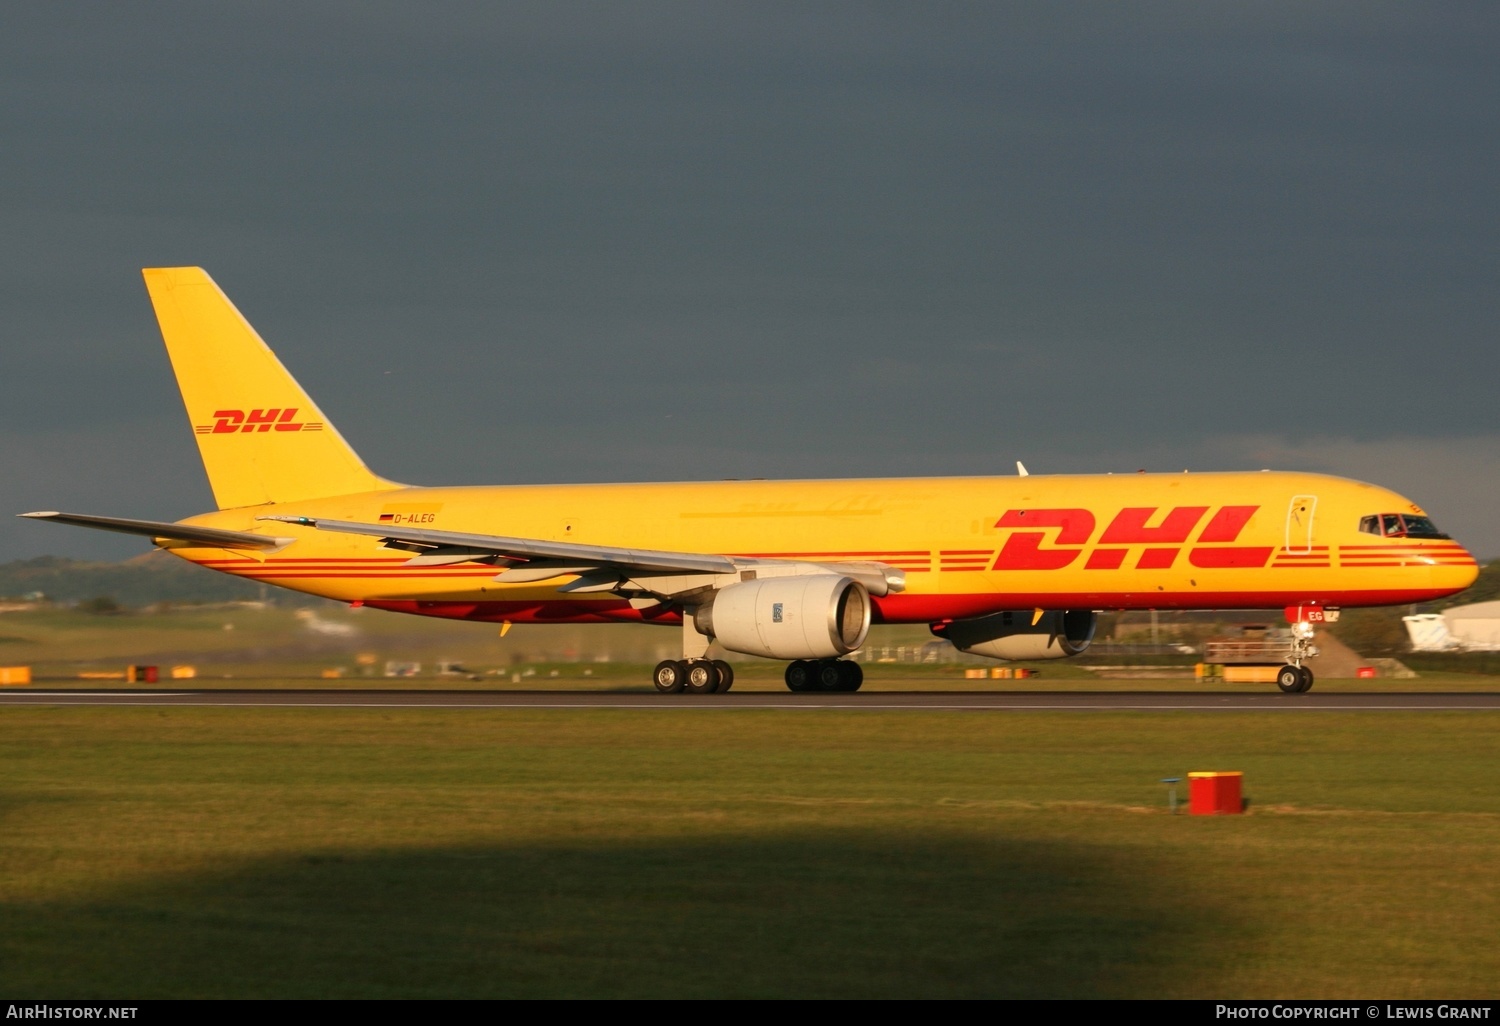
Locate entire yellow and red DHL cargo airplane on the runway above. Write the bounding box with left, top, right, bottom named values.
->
left=20, top=267, right=1479, bottom=693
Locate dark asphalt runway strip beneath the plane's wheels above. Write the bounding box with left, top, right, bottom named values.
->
left=0, top=690, right=1500, bottom=713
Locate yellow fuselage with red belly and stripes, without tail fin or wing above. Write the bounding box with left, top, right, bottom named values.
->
left=167, top=473, right=1478, bottom=623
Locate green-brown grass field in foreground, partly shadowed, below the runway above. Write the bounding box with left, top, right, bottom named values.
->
left=0, top=707, right=1500, bottom=999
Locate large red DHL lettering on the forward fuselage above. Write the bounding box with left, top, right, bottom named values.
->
left=992, top=506, right=1274, bottom=570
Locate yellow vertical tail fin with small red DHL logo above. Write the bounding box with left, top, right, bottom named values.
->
left=141, top=267, right=401, bottom=510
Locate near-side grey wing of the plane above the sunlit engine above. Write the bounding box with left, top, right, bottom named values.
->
left=258, top=516, right=905, bottom=596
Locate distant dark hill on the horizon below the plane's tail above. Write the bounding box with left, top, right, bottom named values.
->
left=0, top=551, right=310, bottom=606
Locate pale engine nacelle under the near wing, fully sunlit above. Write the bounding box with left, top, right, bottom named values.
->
left=693, top=573, right=870, bottom=659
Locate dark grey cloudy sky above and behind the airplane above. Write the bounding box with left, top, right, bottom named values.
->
left=0, top=2, right=1500, bottom=560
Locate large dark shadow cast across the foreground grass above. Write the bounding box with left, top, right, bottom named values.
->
left=0, top=831, right=1242, bottom=998
